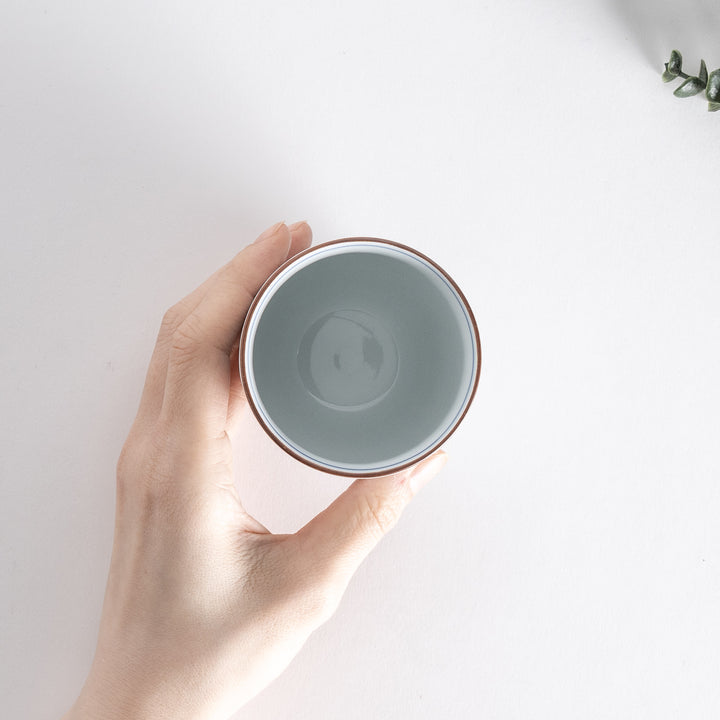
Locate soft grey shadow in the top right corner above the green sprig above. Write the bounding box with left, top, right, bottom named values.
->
left=609, top=0, right=720, bottom=67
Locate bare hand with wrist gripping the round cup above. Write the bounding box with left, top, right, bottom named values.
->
left=65, top=223, right=446, bottom=720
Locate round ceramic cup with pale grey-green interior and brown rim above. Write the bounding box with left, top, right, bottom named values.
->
left=239, top=238, right=480, bottom=477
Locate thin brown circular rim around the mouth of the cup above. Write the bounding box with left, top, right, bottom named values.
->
left=238, top=237, right=482, bottom=478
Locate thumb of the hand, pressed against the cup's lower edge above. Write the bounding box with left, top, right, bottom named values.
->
left=297, top=450, right=448, bottom=588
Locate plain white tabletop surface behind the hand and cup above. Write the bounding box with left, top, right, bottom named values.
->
left=0, top=0, right=720, bottom=720
